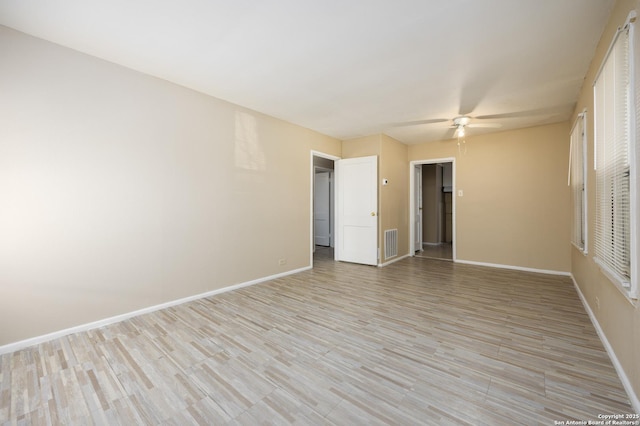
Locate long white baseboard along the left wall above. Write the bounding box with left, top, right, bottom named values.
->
left=0, top=266, right=311, bottom=355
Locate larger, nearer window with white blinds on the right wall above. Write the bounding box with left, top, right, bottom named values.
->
left=593, top=15, right=637, bottom=298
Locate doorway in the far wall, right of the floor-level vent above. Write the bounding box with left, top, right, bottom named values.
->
left=410, top=158, right=456, bottom=261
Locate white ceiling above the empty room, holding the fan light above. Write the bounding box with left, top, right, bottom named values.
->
left=0, top=0, right=614, bottom=144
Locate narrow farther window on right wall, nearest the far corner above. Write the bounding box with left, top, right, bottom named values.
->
left=569, top=111, right=587, bottom=253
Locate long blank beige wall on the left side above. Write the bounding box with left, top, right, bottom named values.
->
left=0, top=27, right=341, bottom=346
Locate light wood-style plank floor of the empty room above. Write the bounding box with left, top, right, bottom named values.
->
left=0, top=249, right=632, bottom=425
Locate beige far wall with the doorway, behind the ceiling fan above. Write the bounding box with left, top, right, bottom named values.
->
left=409, top=122, right=570, bottom=272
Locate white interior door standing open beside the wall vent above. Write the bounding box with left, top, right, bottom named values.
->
left=335, top=156, right=378, bottom=265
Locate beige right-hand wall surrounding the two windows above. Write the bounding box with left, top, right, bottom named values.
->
left=571, top=0, right=640, bottom=409
